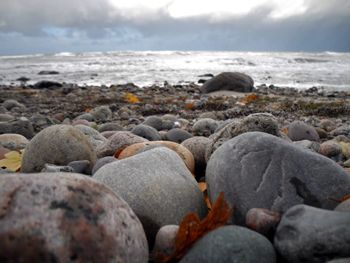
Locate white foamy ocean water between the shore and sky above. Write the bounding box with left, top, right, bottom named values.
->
left=0, top=51, right=350, bottom=90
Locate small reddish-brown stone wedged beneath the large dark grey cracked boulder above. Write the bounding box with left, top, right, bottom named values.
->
left=245, top=208, right=281, bottom=239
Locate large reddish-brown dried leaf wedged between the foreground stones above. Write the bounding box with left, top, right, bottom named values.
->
left=155, top=192, right=232, bottom=263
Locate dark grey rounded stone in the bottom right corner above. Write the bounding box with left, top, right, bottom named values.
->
left=274, top=205, right=350, bottom=263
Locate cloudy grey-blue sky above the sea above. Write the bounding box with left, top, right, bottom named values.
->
left=0, top=0, right=350, bottom=55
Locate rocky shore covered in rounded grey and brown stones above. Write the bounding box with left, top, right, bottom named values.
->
left=0, top=73, right=350, bottom=262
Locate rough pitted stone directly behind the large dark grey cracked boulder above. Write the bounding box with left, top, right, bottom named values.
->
left=205, top=113, right=282, bottom=161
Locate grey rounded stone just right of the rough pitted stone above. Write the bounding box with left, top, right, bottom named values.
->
left=288, top=121, right=320, bottom=142
